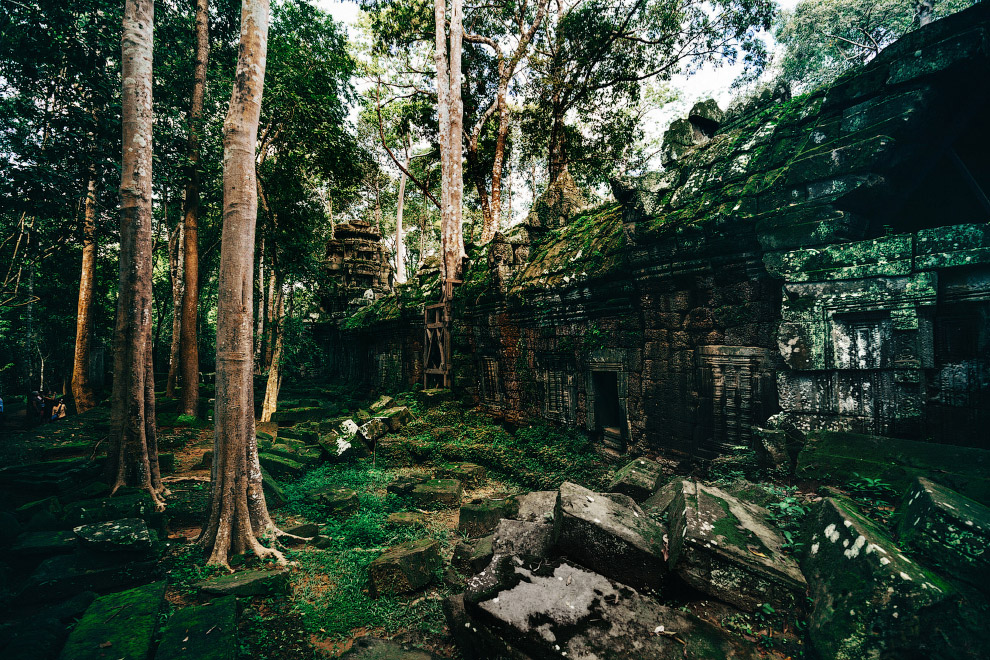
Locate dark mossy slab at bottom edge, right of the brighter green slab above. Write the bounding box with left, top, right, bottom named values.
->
left=155, top=596, right=238, bottom=660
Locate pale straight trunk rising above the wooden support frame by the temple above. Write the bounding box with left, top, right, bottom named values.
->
left=434, top=0, right=464, bottom=292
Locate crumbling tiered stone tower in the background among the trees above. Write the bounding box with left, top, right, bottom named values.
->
left=321, top=220, right=393, bottom=317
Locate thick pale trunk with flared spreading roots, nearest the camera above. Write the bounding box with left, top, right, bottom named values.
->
left=198, top=0, right=285, bottom=568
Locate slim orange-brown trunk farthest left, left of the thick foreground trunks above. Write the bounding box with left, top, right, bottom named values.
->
left=72, top=171, right=96, bottom=413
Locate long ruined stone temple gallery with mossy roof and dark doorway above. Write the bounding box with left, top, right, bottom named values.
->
left=326, top=5, right=990, bottom=456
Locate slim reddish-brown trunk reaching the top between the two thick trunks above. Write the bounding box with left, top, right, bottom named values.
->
left=179, top=0, right=210, bottom=417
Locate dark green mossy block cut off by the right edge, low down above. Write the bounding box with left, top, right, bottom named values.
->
left=899, top=477, right=990, bottom=591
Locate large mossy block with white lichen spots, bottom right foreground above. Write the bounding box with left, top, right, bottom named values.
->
left=801, top=498, right=953, bottom=660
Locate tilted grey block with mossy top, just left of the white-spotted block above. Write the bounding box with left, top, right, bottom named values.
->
left=669, top=481, right=807, bottom=611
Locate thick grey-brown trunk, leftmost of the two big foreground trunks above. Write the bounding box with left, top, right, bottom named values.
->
left=107, top=0, right=165, bottom=509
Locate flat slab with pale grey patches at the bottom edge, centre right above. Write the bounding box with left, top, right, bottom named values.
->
left=470, top=562, right=759, bottom=660
